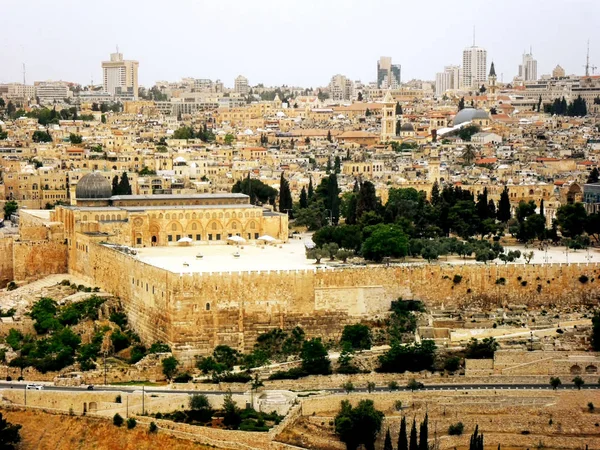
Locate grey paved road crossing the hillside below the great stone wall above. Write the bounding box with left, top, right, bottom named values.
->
left=0, top=382, right=600, bottom=395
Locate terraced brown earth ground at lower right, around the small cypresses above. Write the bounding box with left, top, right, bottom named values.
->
left=277, top=390, right=600, bottom=450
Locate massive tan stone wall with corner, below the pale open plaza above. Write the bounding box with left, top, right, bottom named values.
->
left=64, top=241, right=600, bottom=357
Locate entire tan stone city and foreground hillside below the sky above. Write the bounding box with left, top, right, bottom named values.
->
left=0, top=9, right=600, bottom=450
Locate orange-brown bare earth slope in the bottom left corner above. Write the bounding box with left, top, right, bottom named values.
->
left=1, top=410, right=226, bottom=450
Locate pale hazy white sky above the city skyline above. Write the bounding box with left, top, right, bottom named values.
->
left=0, top=0, right=600, bottom=86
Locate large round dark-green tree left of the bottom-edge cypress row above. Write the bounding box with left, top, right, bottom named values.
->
left=334, top=400, right=384, bottom=450
